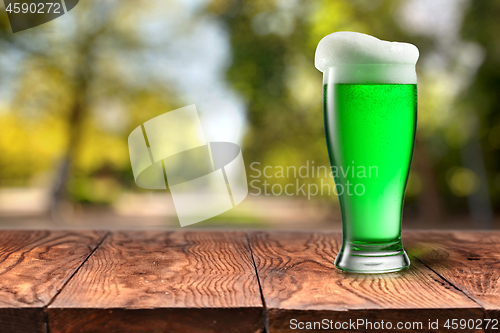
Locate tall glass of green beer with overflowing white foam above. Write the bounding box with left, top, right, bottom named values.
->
left=315, top=32, right=418, bottom=273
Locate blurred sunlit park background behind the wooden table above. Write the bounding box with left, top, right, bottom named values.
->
left=0, top=0, right=500, bottom=229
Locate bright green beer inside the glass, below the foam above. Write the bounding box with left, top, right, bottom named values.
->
left=324, top=84, right=417, bottom=270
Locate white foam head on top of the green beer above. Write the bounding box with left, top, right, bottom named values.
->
left=314, top=31, right=418, bottom=84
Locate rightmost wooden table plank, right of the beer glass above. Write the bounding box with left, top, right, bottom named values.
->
left=407, top=231, right=500, bottom=329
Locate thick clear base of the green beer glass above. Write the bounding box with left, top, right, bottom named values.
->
left=335, top=242, right=410, bottom=274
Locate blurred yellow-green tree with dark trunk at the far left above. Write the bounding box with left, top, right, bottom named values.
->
left=0, top=0, right=178, bottom=218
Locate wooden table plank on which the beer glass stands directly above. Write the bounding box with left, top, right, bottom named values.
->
left=249, top=232, right=483, bottom=332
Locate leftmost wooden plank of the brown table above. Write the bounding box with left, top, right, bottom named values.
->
left=0, top=230, right=105, bottom=333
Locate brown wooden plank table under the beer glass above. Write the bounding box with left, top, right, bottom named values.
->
left=0, top=230, right=500, bottom=333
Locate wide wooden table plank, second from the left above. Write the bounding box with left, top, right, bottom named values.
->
left=48, top=231, right=264, bottom=333
